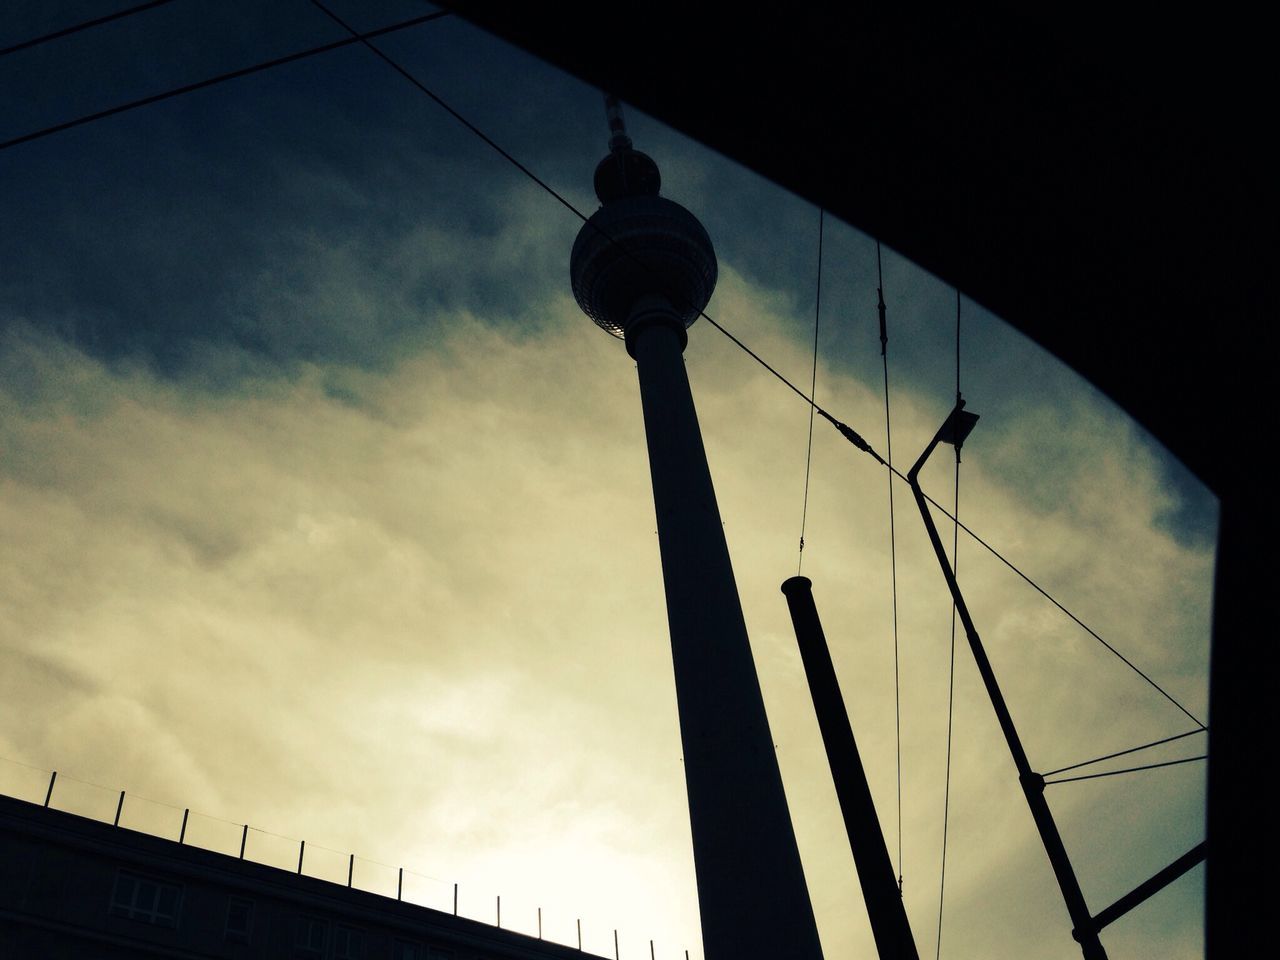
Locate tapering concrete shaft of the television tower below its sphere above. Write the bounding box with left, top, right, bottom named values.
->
left=627, top=298, right=822, bottom=960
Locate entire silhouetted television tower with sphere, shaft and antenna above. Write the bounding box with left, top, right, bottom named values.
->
left=570, top=97, right=822, bottom=960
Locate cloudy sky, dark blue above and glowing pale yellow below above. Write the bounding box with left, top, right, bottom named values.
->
left=0, top=0, right=1216, bottom=960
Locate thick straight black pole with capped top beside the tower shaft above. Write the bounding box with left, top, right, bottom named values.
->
left=782, top=576, right=919, bottom=960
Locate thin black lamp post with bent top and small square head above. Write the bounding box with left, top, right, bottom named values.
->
left=906, top=399, right=1107, bottom=960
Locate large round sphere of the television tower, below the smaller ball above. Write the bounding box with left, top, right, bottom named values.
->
left=570, top=191, right=717, bottom=338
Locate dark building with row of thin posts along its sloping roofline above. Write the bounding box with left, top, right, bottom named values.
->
left=0, top=796, right=585, bottom=960
